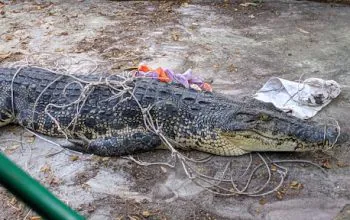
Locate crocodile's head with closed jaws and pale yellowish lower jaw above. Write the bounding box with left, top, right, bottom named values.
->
left=220, top=109, right=348, bottom=155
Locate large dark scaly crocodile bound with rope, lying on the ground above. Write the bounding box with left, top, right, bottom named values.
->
left=0, top=67, right=348, bottom=156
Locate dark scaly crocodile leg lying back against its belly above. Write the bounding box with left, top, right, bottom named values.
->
left=62, top=131, right=162, bottom=156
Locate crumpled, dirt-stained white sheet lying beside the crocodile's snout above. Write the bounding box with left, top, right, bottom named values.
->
left=254, top=77, right=341, bottom=119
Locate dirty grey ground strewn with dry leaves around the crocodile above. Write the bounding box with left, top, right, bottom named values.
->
left=0, top=0, right=350, bottom=220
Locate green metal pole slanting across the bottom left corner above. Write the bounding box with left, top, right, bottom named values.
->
left=0, top=152, right=85, bottom=220
